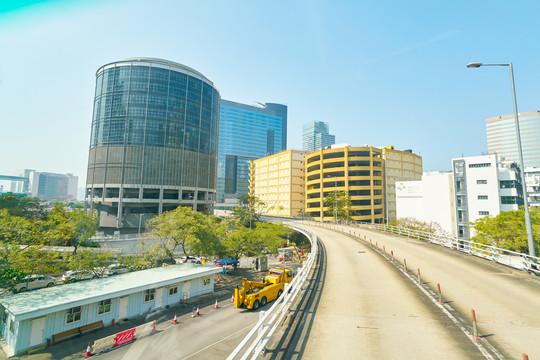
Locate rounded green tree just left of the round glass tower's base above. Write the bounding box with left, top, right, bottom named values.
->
left=46, top=202, right=98, bottom=254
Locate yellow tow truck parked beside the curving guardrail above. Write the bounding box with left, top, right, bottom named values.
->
left=234, top=267, right=292, bottom=310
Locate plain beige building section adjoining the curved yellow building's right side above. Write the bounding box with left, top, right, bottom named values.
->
left=381, top=146, right=422, bottom=222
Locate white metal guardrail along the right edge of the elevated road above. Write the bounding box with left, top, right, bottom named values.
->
left=303, top=220, right=540, bottom=275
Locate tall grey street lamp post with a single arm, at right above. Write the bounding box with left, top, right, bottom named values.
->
left=467, top=62, right=536, bottom=257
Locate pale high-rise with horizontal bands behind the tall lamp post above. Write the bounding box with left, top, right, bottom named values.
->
left=486, top=110, right=540, bottom=168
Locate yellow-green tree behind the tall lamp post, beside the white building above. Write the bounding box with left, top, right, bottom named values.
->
left=470, top=207, right=540, bottom=254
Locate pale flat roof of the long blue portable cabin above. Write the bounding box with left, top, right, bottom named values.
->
left=0, top=264, right=222, bottom=321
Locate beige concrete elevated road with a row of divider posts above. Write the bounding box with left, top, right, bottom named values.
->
left=288, top=224, right=540, bottom=359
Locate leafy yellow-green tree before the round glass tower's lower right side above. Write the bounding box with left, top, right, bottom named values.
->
left=143, top=206, right=217, bottom=259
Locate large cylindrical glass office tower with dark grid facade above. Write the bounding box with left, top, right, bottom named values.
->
left=86, top=58, right=220, bottom=232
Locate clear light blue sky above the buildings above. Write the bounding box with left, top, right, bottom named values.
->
left=0, top=0, right=540, bottom=186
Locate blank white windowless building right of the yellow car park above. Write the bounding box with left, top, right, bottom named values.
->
left=395, top=171, right=456, bottom=236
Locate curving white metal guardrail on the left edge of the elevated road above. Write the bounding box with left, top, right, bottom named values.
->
left=227, top=222, right=318, bottom=360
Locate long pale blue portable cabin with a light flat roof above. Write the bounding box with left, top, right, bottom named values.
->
left=0, top=264, right=221, bottom=356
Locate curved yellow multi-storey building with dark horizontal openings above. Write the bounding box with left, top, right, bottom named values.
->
left=305, top=145, right=384, bottom=223
